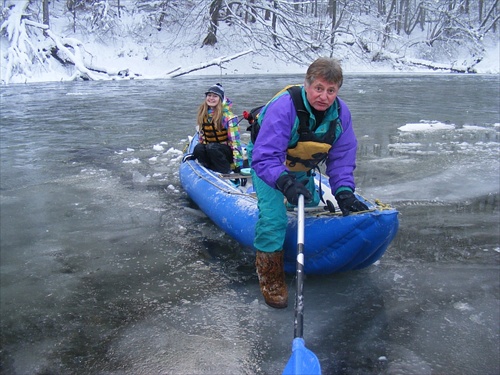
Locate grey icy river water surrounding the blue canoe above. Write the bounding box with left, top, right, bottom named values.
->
left=0, top=74, right=500, bottom=375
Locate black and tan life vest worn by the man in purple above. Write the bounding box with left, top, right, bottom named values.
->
left=286, top=86, right=342, bottom=172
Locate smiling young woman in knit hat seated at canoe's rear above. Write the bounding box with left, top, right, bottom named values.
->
left=190, top=83, right=243, bottom=173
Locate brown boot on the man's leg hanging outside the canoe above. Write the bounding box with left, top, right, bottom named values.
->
left=255, top=250, right=288, bottom=309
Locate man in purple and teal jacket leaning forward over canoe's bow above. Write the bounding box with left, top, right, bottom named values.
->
left=249, top=58, right=368, bottom=308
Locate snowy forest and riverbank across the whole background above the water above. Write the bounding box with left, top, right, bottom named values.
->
left=0, top=0, right=500, bottom=84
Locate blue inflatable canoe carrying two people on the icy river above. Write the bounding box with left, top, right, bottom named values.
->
left=179, top=136, right=399, bottom=274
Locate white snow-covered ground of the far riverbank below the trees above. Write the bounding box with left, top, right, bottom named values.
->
left=0, top=0, right=500, bottom=83
